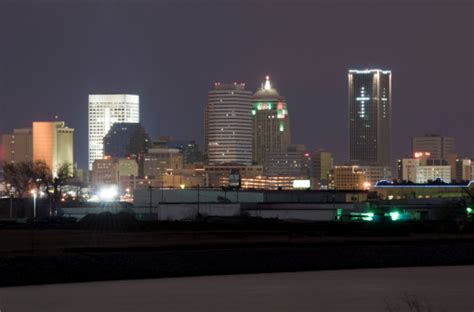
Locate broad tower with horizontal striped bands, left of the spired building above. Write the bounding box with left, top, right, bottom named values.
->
left=204, top=83, right=252, bottom=165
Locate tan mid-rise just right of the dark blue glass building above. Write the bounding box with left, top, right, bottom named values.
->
left=143, top=148, right=183, bottom=180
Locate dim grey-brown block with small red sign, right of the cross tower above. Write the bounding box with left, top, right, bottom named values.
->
left=412, top=134, right=456, bottom=160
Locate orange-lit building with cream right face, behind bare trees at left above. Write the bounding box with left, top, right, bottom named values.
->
left=33, top=121, right=74, bottom=176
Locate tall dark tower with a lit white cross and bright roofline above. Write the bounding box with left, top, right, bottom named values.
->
left=348, top=69, right=392, bottom=167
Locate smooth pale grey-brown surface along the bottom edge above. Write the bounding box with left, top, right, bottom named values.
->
left=0, top=266, right=474, bottom=312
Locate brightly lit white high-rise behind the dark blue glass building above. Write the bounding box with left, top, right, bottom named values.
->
left=89, top=94, right=140, bottom=170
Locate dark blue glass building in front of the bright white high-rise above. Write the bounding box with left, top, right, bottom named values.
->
left=104, top=122, right=151, bottom=158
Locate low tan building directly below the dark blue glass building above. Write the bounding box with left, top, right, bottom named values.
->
left=91, top=157, right=138, bottom=193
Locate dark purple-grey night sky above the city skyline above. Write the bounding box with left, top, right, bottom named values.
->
left=0, top=0, right=474, bottom=171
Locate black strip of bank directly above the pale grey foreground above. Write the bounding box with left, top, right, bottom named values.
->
left=0, top=239, right=474, bottom=286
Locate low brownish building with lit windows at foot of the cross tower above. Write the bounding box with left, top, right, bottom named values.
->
left=330, top=166, right=368, bottom=190
